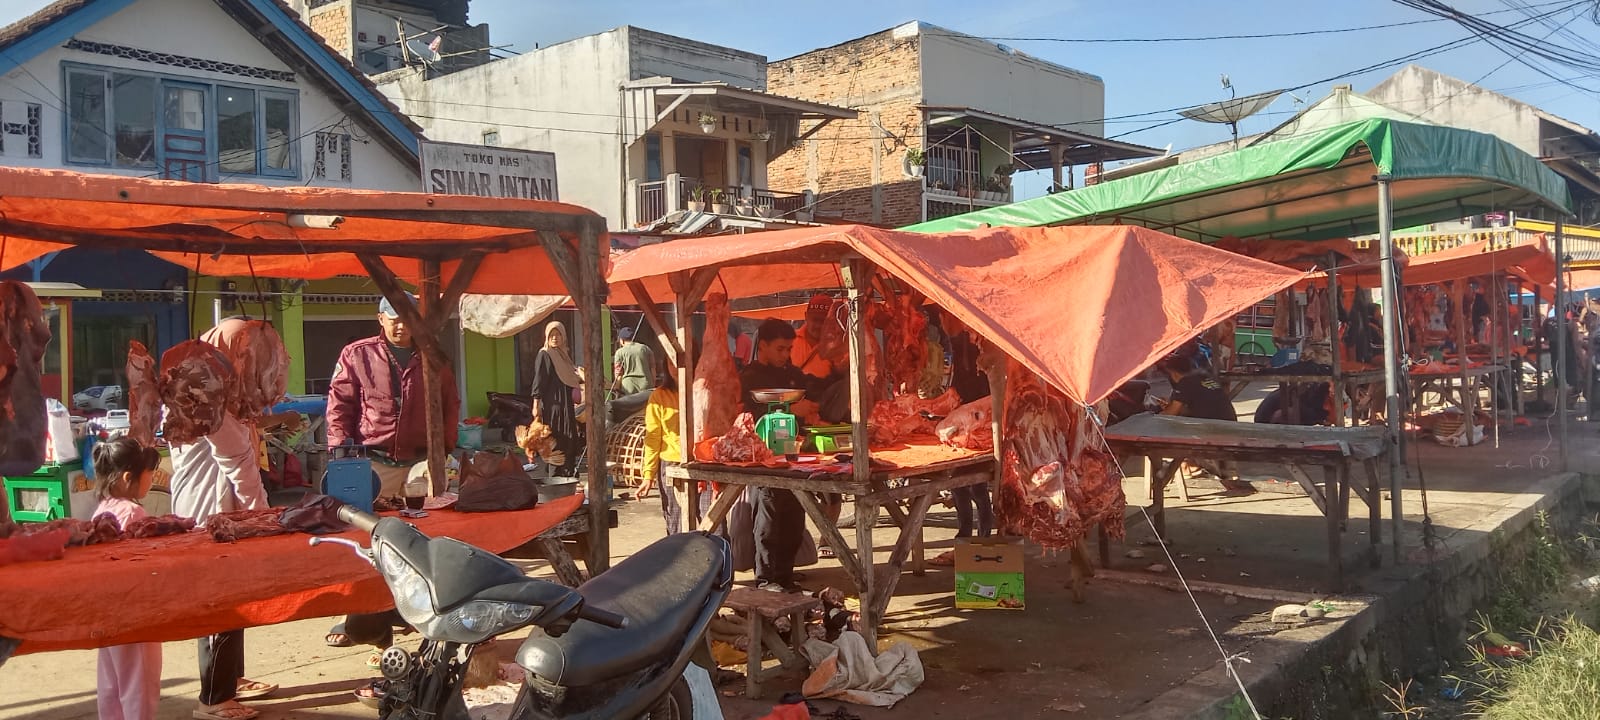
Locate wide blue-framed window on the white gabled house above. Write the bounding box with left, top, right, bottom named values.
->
left=64, top=64, right=299, bottom=181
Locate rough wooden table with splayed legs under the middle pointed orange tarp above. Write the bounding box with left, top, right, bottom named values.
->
left=667, top=438, right=998, bottom=648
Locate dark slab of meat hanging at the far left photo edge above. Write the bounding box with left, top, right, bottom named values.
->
left=0, top=280, right=50, bottom=476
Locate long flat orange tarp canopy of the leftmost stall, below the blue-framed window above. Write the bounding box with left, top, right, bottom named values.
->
left=0, top=168, right=606, bottom=294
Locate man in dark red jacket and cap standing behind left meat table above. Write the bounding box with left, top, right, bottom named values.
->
left=326, top=294, right=461, bottom=665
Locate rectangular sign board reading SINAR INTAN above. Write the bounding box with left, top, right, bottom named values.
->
left=421, top=141, right=558, bottom=200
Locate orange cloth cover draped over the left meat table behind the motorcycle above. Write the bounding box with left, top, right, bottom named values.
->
left=0, top=496, right=582, bottom=654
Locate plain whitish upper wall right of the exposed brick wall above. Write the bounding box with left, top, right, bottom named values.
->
left=915, top=22, right=1106, bottom=136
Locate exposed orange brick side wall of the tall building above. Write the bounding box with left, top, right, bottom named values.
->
left=766, top=32, right=922, bottom=227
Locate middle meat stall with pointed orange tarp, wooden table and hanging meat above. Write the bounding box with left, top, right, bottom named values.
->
left=610, top=226, right=1304, bottom=645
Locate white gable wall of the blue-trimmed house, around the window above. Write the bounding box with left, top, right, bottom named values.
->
left=0, top=0, right=421, bottom=190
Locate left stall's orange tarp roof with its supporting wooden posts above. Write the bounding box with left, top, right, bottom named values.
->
left=0, top=168, right=610, bottom=571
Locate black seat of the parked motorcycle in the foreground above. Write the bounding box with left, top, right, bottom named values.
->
left=517, top=533, right=733, bottom=686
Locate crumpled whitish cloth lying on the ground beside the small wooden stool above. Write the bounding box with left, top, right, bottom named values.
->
left=800, top=632, right=923, bottom=707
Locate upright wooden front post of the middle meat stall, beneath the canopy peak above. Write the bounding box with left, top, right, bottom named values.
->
left=840, top=258, right=883, bottom=654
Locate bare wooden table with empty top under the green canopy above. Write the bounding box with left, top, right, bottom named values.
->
left=1106, top=414, right=1389, bottom=590
